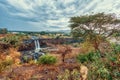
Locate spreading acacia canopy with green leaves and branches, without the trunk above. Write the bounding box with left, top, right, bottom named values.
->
left=70, top=13, right=120, bottom=37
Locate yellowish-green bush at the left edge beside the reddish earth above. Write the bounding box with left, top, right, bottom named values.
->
left=0, top=59, right=13, bottom=72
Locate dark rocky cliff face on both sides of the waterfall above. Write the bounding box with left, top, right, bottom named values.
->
left=18, top=38, right=81, bottom=51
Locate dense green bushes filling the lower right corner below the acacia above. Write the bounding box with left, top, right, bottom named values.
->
left=77, top=45, right=120, bottom=80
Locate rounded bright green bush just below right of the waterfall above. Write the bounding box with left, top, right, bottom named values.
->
left=38, top=55, right=57, bottom=64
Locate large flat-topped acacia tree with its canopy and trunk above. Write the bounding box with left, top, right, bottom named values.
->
left=70, top=13, right=120, bottom=50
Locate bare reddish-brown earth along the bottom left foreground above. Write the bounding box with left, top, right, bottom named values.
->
left=0, top=63, right=80, bottom=80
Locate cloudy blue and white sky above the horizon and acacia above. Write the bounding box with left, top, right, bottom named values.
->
left=0, top=0, right=120, bottom=31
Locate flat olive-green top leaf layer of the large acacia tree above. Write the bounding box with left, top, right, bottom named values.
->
left=70, top=13, right=120, bottom=24
